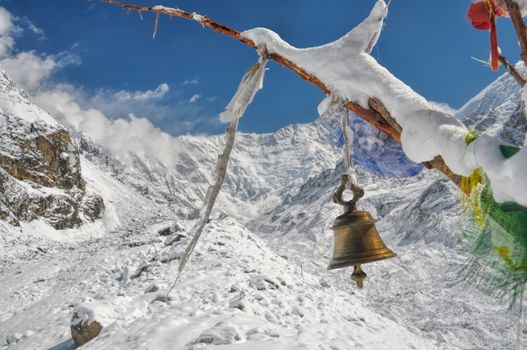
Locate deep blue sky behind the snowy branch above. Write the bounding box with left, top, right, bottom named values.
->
left=0, top=0, right=519, bottom=134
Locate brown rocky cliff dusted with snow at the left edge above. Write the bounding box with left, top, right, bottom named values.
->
left=0, top=73, right=104, bottom=229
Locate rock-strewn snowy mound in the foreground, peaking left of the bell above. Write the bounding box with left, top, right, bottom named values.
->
left=0, top=217, right=435, bottom=350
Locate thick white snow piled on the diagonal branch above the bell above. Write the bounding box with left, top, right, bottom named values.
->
left=242, top=0, right=527, bottom=206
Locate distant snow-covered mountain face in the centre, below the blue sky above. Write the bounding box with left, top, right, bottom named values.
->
left=81, top=123, right=340, bottom=222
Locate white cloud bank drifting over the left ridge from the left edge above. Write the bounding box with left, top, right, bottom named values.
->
left=0, top=7, right=220, bottom=165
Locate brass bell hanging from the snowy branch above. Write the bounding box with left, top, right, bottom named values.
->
left=328, top=175, right=396, bottom=288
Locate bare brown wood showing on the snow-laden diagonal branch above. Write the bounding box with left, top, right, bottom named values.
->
left=101, top=0, right=462, bottom=186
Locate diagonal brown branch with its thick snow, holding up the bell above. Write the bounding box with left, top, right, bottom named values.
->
left=102, top=0, right=527, bottom=205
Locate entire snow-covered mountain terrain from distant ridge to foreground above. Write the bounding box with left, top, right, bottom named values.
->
left=0, top=66, right=525, bottom=350
